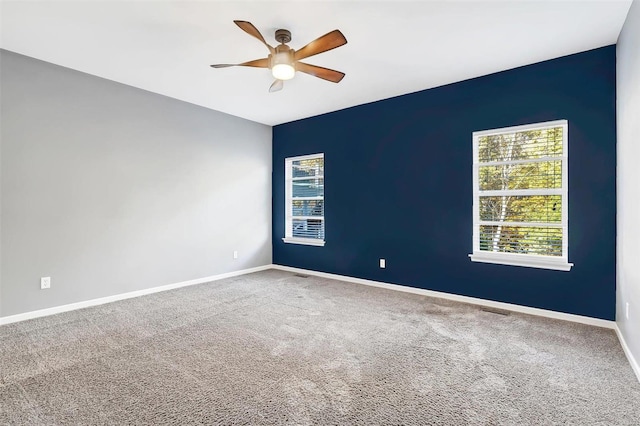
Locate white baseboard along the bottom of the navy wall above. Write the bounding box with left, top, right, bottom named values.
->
left=272, top=264, right=616, bottom=329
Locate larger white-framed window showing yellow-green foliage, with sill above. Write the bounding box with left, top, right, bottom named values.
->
left=469, top=120, right=573, bottom=271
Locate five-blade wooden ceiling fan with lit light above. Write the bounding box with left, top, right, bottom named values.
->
left=211, top=21, right=347, bottom=92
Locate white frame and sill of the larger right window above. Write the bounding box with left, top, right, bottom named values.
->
left=469, top=120, right=573, bottom=271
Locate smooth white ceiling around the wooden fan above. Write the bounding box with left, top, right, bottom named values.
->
left=0, top=0, right=631, bottom=125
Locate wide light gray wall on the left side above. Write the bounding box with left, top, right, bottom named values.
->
left=0, top=51, right=271, bottom=317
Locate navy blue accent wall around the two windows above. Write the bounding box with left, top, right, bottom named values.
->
left=273, top=46, right=616, bottom=320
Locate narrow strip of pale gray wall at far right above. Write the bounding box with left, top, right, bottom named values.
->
left=616, top=0, right=640, bottom=372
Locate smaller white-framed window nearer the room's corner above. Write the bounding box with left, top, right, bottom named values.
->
left=282, top=154, right=324, bottom=246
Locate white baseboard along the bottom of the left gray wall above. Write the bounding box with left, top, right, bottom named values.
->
left=0, top=265, right=271, bottom=325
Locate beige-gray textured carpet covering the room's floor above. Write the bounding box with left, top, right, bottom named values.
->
left=0, top=270, right=640, bottom=425
